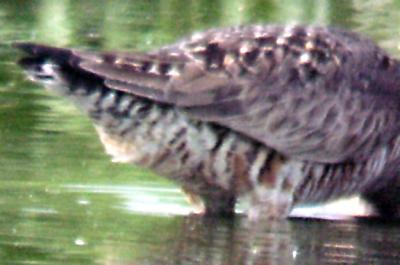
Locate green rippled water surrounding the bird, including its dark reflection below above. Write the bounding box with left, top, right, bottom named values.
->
left=0, top=0, right=400, bottom=265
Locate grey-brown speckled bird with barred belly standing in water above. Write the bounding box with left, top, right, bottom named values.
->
left=13, top=24, right=400, bottom=220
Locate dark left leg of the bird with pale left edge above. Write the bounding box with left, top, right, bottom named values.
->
left=182, top=186, right=236, bottom=217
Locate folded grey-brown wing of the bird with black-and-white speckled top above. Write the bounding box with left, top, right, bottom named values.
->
left=23, top=26, right=400, bottom=163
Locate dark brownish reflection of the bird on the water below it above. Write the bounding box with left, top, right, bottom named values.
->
left=107, top=216, right=400, bottom=265
